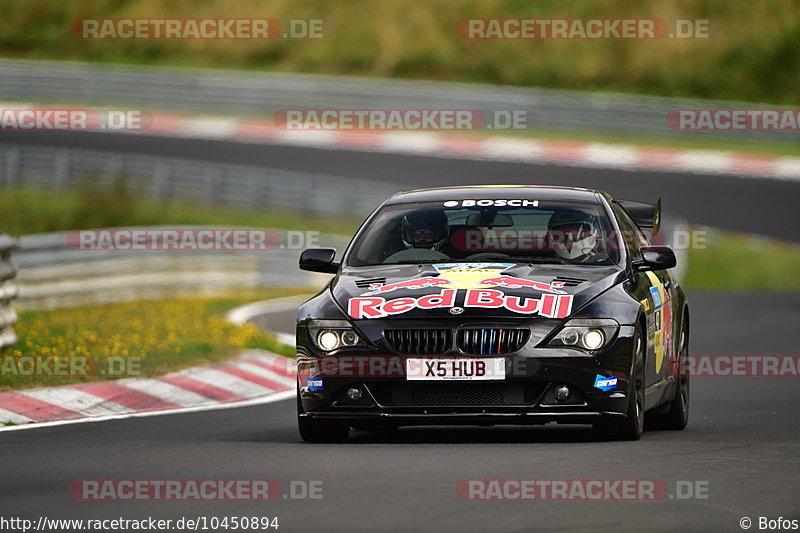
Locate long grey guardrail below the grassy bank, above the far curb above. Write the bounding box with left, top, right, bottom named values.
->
left=0, top=59, right=800, bottom=141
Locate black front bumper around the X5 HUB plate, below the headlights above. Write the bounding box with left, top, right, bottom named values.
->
left=298, top=326, right=633, bottom=426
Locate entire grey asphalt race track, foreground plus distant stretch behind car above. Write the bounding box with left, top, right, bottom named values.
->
left=0, top=132, right=800, bottom=532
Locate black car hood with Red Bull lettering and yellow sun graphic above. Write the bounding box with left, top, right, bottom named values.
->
left=330, top=263, right=623, bottom=320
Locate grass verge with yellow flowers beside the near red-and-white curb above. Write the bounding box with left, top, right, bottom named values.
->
left=0, top=288, right=308, bottom=390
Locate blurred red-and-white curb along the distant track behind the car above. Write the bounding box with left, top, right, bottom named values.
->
left=144, top=113, right=800, bottom=181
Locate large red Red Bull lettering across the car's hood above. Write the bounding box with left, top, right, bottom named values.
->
left=348, top=289, right=572, bottom=319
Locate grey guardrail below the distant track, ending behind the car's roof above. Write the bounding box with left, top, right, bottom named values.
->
left=0, top=144, right=402, bottom=218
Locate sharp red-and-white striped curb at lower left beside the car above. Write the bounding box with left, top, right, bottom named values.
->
left=0, top=350, right=296, bottom=432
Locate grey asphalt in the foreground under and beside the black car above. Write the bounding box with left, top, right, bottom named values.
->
left=0, top=293, right=800, bottom=532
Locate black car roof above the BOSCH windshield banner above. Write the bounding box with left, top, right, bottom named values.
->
left=386, top=185, right=606, bottom=205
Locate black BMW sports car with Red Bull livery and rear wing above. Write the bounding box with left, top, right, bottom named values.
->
left=297, top=186, right=689, bottom=442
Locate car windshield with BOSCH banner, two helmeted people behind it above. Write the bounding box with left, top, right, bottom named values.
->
left=346, top=199, right=620, bottom=266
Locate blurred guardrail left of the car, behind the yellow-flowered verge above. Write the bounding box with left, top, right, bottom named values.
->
left=15, top=226, right=347, bottom=309
